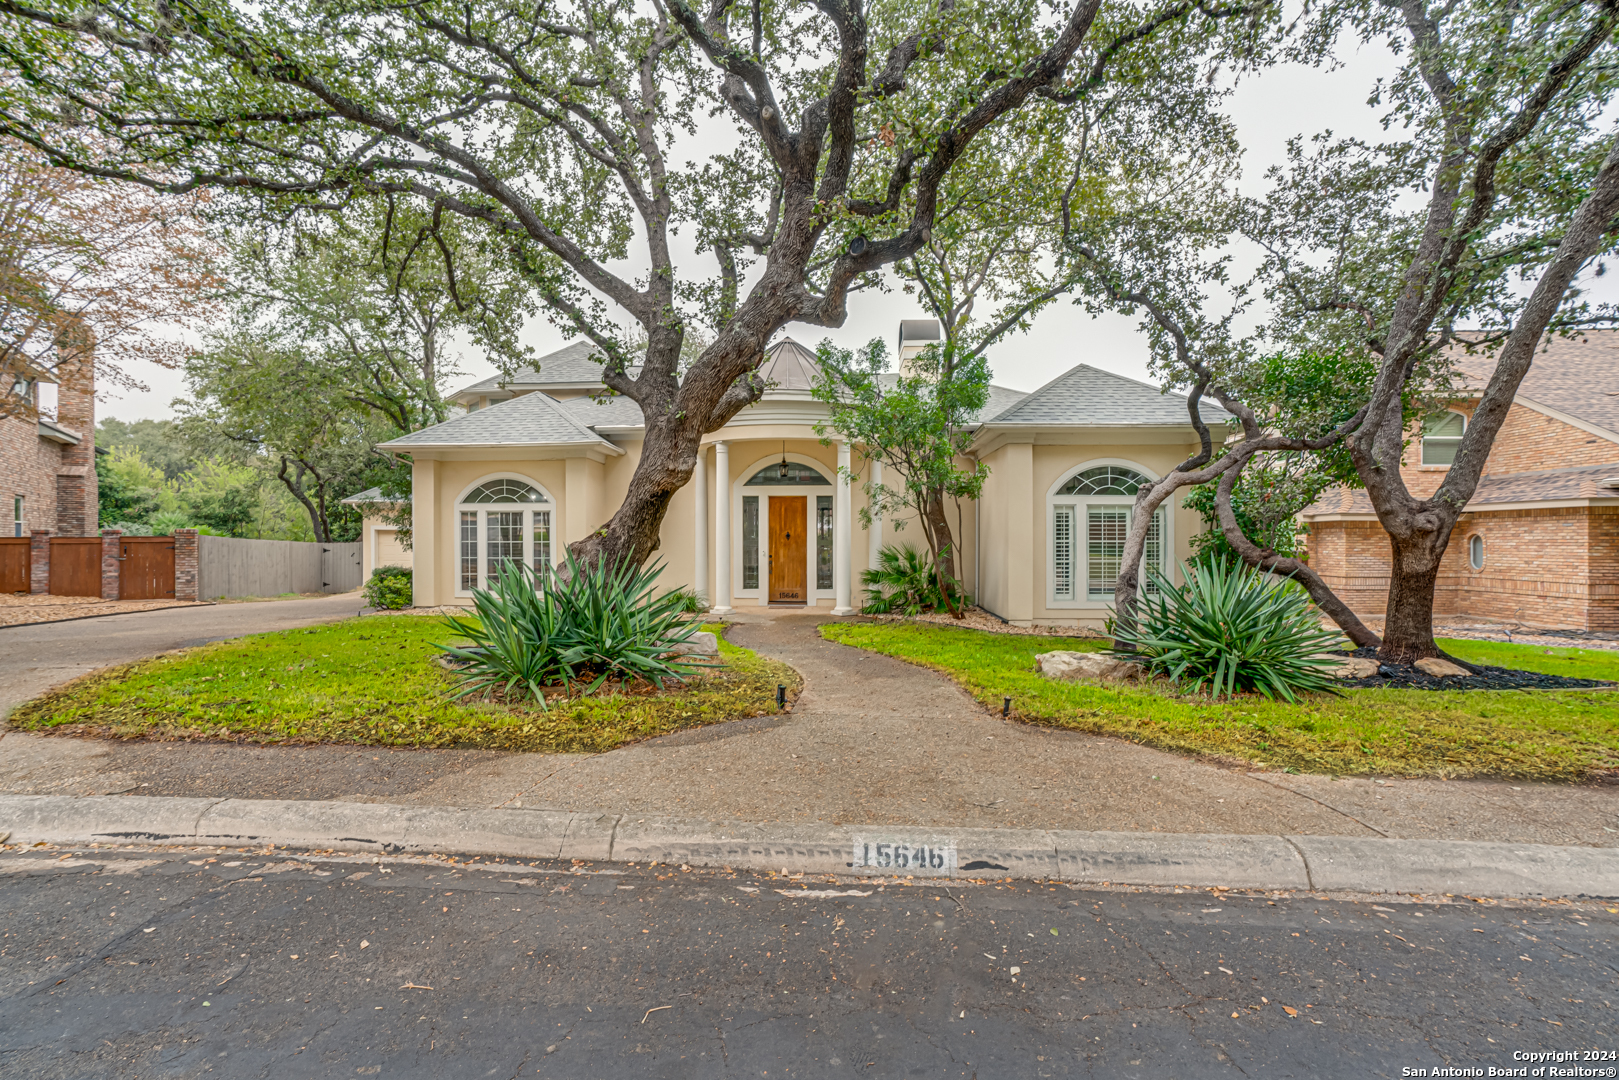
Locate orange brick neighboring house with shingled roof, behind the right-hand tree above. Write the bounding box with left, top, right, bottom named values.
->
left=1302, top=330, right=1619, bottom=633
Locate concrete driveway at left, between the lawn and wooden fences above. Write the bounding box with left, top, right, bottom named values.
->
left=0, top=593, right=361, bottom=719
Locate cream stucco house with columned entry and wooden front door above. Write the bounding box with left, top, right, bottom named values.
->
left=366, top=321, right=1224, bottom=625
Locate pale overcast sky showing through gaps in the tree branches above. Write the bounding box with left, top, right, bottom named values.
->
left=99, top=33, right=1394, bottom=419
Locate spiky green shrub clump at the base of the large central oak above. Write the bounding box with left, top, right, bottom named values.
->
left=444, top=552, right=708, bottom=708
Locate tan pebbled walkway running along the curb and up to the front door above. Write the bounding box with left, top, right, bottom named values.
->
left=0, top=601, right=1619, bottom=847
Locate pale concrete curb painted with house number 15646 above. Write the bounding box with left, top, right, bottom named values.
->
left=0, top=795, right=1619, bottom=897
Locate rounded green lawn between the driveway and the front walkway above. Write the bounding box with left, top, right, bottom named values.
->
left=10, top=615, right=798, bottom=753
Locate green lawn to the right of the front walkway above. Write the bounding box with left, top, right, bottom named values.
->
left=821, top=623, right=1619, bottom=780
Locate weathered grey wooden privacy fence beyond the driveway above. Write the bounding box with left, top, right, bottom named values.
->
left=198, top=536, right=361, bottom=601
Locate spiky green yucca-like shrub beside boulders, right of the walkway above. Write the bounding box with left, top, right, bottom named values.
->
left=1107, top=559, right=1342, bottom=701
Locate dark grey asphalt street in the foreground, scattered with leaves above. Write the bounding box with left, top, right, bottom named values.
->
left=0, top=847, right=1619, bottom=1080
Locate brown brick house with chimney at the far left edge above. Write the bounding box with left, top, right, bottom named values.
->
left=0, top=341, right=99, bottom=536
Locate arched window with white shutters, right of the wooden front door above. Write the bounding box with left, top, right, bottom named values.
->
left=1051, top=465, right=1167, bottom=604
